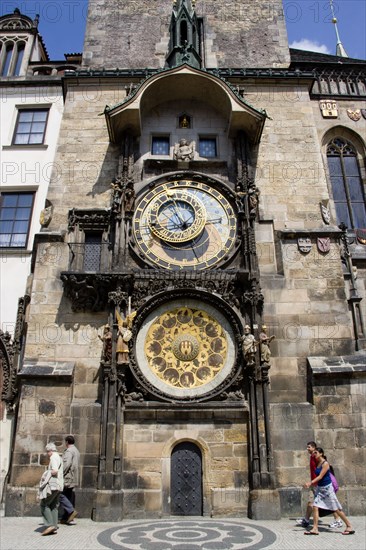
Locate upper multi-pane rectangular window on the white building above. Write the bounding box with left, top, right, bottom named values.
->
left=13, top=109, right=48, bottom=145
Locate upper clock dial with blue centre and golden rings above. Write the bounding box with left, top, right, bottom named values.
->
left=132, top=180, right=237, bottom=270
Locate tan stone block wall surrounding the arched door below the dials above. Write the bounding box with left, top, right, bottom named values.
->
left=123, top=406, right=249, bottom=518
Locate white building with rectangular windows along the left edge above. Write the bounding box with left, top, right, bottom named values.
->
left=0, top=9, right=79, bottom=506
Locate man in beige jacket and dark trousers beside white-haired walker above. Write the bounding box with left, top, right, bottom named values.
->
left=60, top=435, right=80, bottom=525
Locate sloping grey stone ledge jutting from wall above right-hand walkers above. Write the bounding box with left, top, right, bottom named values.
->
left=308, top=351, right=366, bottom=376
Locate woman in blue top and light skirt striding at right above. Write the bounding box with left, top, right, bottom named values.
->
left=304, top=447, right=355, bottom=535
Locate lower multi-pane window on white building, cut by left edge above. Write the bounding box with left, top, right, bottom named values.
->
left=0, top=193, right=34, bottom=248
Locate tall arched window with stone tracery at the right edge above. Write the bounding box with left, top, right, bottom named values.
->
left=327, top=137, right=366, bottom=229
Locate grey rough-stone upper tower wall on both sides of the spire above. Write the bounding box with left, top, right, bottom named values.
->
left=83, top=0, right=290, bottom=68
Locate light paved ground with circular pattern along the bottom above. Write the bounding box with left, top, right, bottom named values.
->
left=0, top=517, right=366, bottom=550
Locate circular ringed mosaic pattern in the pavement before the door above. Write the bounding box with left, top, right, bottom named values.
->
left=98, top=519, right=276, bottom=550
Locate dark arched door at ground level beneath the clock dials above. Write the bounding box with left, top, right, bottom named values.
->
left=170, top=441, right=202, bottom=516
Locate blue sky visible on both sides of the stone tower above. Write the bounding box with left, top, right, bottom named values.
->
left=0, top=0, right=366, bottom=61
